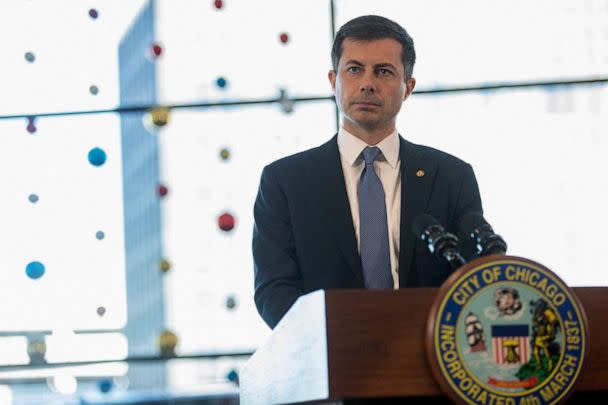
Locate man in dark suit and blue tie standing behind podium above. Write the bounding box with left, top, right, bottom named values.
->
left=253, top=16, right=482, bottom=328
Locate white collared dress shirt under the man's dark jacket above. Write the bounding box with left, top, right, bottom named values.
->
left=338, top=128, right=401, bottom=290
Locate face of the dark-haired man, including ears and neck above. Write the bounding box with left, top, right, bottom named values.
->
left=329, top=38, right=416, bottom=135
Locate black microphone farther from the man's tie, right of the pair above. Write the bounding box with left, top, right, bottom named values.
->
left=458, top=212, right=507, bottom=256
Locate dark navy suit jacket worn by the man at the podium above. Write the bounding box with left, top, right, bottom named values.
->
left=253, top=136, right=482, bottom=328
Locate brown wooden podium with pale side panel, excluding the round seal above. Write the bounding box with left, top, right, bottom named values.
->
left=240, top=287, right=608, bottom=405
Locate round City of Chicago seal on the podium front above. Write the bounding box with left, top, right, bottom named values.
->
left=426, top=255, right=589, bottom=405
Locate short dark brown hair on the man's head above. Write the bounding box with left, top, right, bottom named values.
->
left=331, top=15, right=416, bottom=80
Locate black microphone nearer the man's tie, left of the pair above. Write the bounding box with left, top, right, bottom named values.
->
left=412, top=214, right=465, bottom=270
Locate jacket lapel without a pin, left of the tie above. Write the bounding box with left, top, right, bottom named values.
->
left=318, top=136, right=363, bottom=286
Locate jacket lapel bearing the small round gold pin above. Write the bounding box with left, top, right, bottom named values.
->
left=399, top=136, right=436, bottom=287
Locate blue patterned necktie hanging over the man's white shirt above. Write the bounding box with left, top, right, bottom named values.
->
left=358, top=147, right=393, bottom=289
